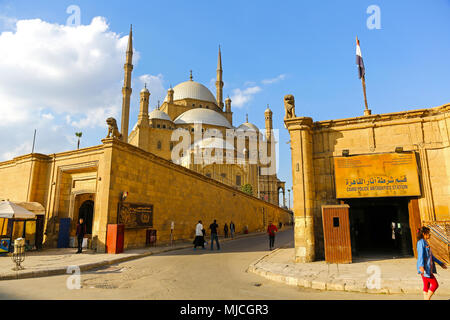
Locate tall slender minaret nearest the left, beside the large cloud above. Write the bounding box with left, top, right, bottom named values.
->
left=120, top=25, right=133, bottom=142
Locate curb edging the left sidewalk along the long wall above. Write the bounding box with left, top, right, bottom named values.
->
left=0, top=232, right=276, bottom=281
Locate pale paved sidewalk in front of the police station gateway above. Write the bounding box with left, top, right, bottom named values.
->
left=248, top=248, right=450, bottom=298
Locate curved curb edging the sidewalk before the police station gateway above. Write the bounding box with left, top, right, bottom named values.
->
left=246, top=248, right=450, bottom=295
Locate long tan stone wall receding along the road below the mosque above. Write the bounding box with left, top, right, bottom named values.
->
left=99, top=139, right=289, bottom=248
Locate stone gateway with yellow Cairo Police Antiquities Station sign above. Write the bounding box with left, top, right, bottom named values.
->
left=284, top=96, right=450, bottom=262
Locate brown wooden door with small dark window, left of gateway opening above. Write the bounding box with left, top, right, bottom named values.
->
left=322, top=204, right=352, bottom=263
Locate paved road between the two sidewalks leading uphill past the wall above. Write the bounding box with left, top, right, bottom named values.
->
left=0, top=229, right=428, bottom=300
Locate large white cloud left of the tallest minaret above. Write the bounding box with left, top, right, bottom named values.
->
left=0, top=16, right=155, bottom=161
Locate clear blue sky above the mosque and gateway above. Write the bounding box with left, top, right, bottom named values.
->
left=0, top=0, right=450, bottom=205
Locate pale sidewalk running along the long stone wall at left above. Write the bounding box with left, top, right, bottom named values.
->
left=0, top=232, right=264, bottom=280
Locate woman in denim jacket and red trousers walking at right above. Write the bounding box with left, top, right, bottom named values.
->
left=417, top=227, right=447, bottom=300
